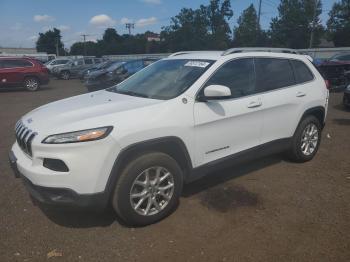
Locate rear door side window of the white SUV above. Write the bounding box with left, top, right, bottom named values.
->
left=255, top=58, right=295, bottom=92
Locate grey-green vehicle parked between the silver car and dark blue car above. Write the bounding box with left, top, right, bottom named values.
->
left=52, top=57, right=103, bottom=80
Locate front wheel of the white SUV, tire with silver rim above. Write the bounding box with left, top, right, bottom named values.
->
left=112, top=152, right=183, bottom=226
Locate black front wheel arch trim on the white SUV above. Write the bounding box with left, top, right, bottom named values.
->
left=105, top=136, right=193, bottom=198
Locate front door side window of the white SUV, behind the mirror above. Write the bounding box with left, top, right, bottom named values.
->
left=206, top=58, right=255, bottom=98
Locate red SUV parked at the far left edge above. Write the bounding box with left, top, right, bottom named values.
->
left=0, top=57, right=49, bottom=91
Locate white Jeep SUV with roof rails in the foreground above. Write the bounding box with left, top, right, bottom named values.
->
left=10, top=49, right=329, bottom=225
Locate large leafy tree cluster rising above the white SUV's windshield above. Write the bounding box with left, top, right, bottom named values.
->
left=161, top=0, right=233, bottom=52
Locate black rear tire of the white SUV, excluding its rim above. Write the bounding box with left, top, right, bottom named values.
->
left=293, top=116, right=322, bottom=162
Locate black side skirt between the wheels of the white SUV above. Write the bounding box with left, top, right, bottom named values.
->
left=185, top=138, right=292, bottom=183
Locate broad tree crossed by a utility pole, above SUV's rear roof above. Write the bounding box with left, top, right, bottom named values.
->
left=269, top=0, right=323, bottom=48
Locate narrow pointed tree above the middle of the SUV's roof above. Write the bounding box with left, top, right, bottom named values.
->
left=234, top=4, right=260, bottom=46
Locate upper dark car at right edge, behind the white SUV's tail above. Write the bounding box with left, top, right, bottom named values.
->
left=317, top=54, right=350, bottom=90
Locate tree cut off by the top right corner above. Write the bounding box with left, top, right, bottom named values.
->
left=327, top=0, right=350, bottom=46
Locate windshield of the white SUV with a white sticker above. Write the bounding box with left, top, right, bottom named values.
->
left=107, top=59, right=214, bottom=100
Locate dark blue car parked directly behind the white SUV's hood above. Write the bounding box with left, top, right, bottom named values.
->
left=85, top=58, right=157, bottom=92
